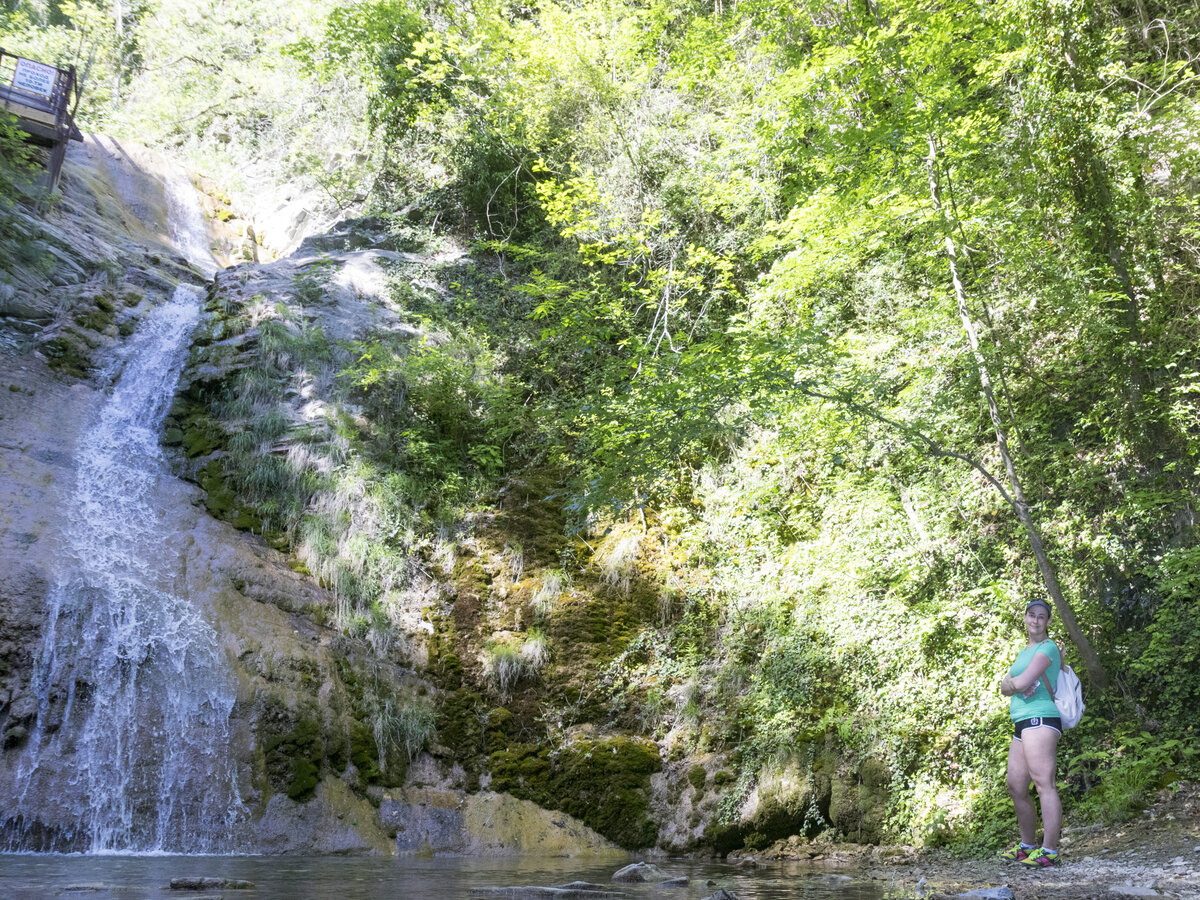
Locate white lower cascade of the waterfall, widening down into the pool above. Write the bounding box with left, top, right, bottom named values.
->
left=5, top=286, right=244, bottom=853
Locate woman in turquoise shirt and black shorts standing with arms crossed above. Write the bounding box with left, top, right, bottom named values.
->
left=1000, top=600, right=1062, bottom=868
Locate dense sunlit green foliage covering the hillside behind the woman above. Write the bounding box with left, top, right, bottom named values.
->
left=5, top=0, right=1200, bottom=854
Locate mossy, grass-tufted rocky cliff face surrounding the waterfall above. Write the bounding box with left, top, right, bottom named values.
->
left=0, top=139, right=889, bottom=854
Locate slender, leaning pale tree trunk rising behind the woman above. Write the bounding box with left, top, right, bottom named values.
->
left=929, top=136, right=1108, bottom=690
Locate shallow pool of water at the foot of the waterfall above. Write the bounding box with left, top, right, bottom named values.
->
left=0, top=854, right=902, bottom=900
